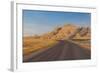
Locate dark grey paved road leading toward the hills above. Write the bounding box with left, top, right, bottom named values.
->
left=24, top=40, right=91, bottom=62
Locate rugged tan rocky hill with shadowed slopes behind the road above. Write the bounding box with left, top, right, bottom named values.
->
left=40, top=24, right=91, bottom=40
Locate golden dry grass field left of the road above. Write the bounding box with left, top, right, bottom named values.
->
left=23, top=37, right=57, bottom=55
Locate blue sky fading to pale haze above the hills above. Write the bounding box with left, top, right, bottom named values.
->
left=22, top=10, right=91, bottom=36
